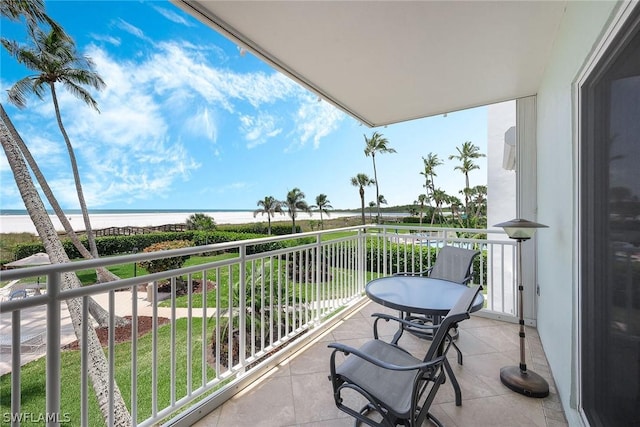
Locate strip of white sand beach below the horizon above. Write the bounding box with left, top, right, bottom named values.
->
left=0, top=211, right=355, bottom=233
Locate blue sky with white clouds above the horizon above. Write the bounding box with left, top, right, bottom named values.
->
left=0, top=1, right=487, bottom=209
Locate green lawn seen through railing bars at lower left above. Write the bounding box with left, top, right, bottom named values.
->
left=0, top=318, right=215, bottom=426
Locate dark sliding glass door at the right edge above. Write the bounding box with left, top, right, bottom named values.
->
left=580, top=7, right=640, bottom=426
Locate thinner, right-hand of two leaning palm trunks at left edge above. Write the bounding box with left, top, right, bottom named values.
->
left=0, top=104, right=128, bottom=326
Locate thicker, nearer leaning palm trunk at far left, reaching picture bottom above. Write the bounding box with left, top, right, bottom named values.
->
left=0, top=113, right=131, bottom=426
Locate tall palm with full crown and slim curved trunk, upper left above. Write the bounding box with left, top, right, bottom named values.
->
left=2, top=27, right=105, bottom=257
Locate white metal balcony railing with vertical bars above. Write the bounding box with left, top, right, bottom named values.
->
left=0, top=226, right=516, bottom=426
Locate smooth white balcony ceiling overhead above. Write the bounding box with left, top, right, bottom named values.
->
left=172, top=0, right=566, bottom=126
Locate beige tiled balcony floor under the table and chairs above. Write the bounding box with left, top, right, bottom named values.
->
left=195, top=302, right=567, bottom=427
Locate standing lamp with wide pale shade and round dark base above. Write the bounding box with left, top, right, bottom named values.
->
left=494, top=218, right=549, bottom=397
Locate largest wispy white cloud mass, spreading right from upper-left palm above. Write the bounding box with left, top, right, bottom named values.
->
left=0, top=26, right=343, bottom=208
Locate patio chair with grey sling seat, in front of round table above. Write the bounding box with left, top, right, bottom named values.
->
left=329, top=286, right=480, bottom=427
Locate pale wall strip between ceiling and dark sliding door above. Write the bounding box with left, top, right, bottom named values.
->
left=537, top=1, right=616, bottom=425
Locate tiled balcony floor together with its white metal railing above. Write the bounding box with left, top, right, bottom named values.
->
left=0, top=226, right=566, bottom=426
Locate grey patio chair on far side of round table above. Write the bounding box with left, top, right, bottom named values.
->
left=396, top=246, right=480, bottom=365
